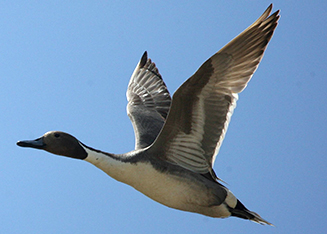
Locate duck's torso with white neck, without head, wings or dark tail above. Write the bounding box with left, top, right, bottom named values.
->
left=85, top=147, right=236, bottom=217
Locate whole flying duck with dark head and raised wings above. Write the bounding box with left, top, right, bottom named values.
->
left=17, top=5, right=279, bottom=225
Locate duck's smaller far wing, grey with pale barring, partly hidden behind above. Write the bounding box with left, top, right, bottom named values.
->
left=126, top=52, right=171, bottom=149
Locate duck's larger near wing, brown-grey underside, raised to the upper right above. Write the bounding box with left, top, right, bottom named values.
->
left=149, top=5, right=279, bottom=177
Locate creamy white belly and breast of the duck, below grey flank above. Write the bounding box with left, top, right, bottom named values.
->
left=93, top=160, right=230, bottom=217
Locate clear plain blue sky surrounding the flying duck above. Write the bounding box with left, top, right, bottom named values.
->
left=0, top=0, right=327, bottom=234
